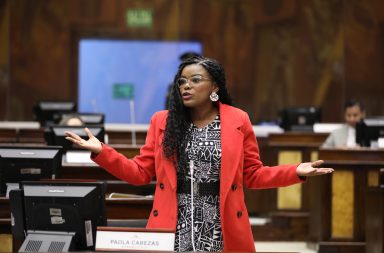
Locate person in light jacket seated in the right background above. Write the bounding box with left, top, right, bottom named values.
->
left=322, top=99, right=365, bottom=148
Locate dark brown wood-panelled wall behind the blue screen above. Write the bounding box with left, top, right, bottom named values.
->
left=0, top=0, right=384, bottom=123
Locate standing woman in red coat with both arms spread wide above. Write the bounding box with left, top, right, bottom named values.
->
left=67, top=57, right=333, bottom=251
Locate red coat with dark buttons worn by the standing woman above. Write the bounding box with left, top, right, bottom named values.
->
left=93, top=104, right=302, bottom=252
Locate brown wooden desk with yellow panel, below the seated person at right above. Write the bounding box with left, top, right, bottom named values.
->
left=309, top=149, right=384, bottom=252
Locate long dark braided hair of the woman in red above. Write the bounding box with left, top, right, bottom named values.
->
left=162, top=56, right=232, bottom=164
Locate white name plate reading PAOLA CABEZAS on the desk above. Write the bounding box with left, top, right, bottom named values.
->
left=95, top=227, right=175, bottom=251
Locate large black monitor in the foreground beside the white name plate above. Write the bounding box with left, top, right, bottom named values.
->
left=10, top=180, right=107, bottom=252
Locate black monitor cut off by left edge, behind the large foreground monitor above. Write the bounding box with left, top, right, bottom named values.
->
left=0, top=146, right=62, bottom=195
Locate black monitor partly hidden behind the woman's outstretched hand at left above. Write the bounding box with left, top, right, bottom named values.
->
left=44, top=125, right=105, bottom=151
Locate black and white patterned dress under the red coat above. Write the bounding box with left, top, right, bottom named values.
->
left=175, top=115, right=224, bottom=251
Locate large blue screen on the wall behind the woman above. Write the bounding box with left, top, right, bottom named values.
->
left=78, top=38, right=203, bottom=124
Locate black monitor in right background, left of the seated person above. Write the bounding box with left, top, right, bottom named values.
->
left=280, top=106, right=321, bottom=132
